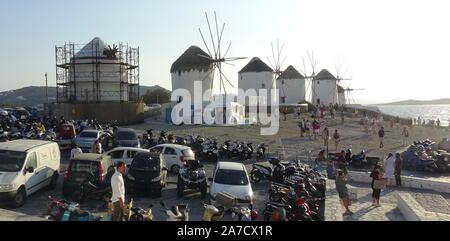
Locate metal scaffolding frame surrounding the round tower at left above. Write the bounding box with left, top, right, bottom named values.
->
left=55, top=39, right=140, bottom=103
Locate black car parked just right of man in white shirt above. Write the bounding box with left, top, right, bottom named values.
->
left=125, top=152, right=167, bottom=197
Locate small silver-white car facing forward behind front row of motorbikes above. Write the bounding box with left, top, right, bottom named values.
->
left=209, top=162, right=253, bottom=205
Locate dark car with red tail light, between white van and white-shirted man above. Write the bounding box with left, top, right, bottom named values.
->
left=62, top=153, right=115, bottom=202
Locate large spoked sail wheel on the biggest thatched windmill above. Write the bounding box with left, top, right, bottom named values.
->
left=198, top=12, right=247, bottom=95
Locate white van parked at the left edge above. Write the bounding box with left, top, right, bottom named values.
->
left=0, top=140, right=61, bottom=207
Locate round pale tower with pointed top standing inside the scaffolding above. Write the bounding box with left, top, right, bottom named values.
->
left=68, top=37, right=129, bottom=102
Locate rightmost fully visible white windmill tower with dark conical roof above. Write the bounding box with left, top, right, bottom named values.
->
left=311, top=69, right=338, bottom=106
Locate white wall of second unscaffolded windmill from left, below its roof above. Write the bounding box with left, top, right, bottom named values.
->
left=238, top=72, right=278, bottom=105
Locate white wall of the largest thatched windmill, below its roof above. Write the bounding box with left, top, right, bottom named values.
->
left=171, top=70, right=214, bottom=104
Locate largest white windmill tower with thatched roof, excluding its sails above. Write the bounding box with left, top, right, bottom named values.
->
left=170, top=46, right=214, bottom=104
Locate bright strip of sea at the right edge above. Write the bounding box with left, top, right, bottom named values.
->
left=376, top=105, right=450, bottom=126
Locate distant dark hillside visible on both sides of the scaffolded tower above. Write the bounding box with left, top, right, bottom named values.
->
left=0, top=85, right=170, bottom=106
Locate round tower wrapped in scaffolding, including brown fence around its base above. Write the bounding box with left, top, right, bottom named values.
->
left=49, top=38, right=144, bottom=124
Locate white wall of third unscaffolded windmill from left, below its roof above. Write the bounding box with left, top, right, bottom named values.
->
left=277, top=79, right=305, bottom=104
